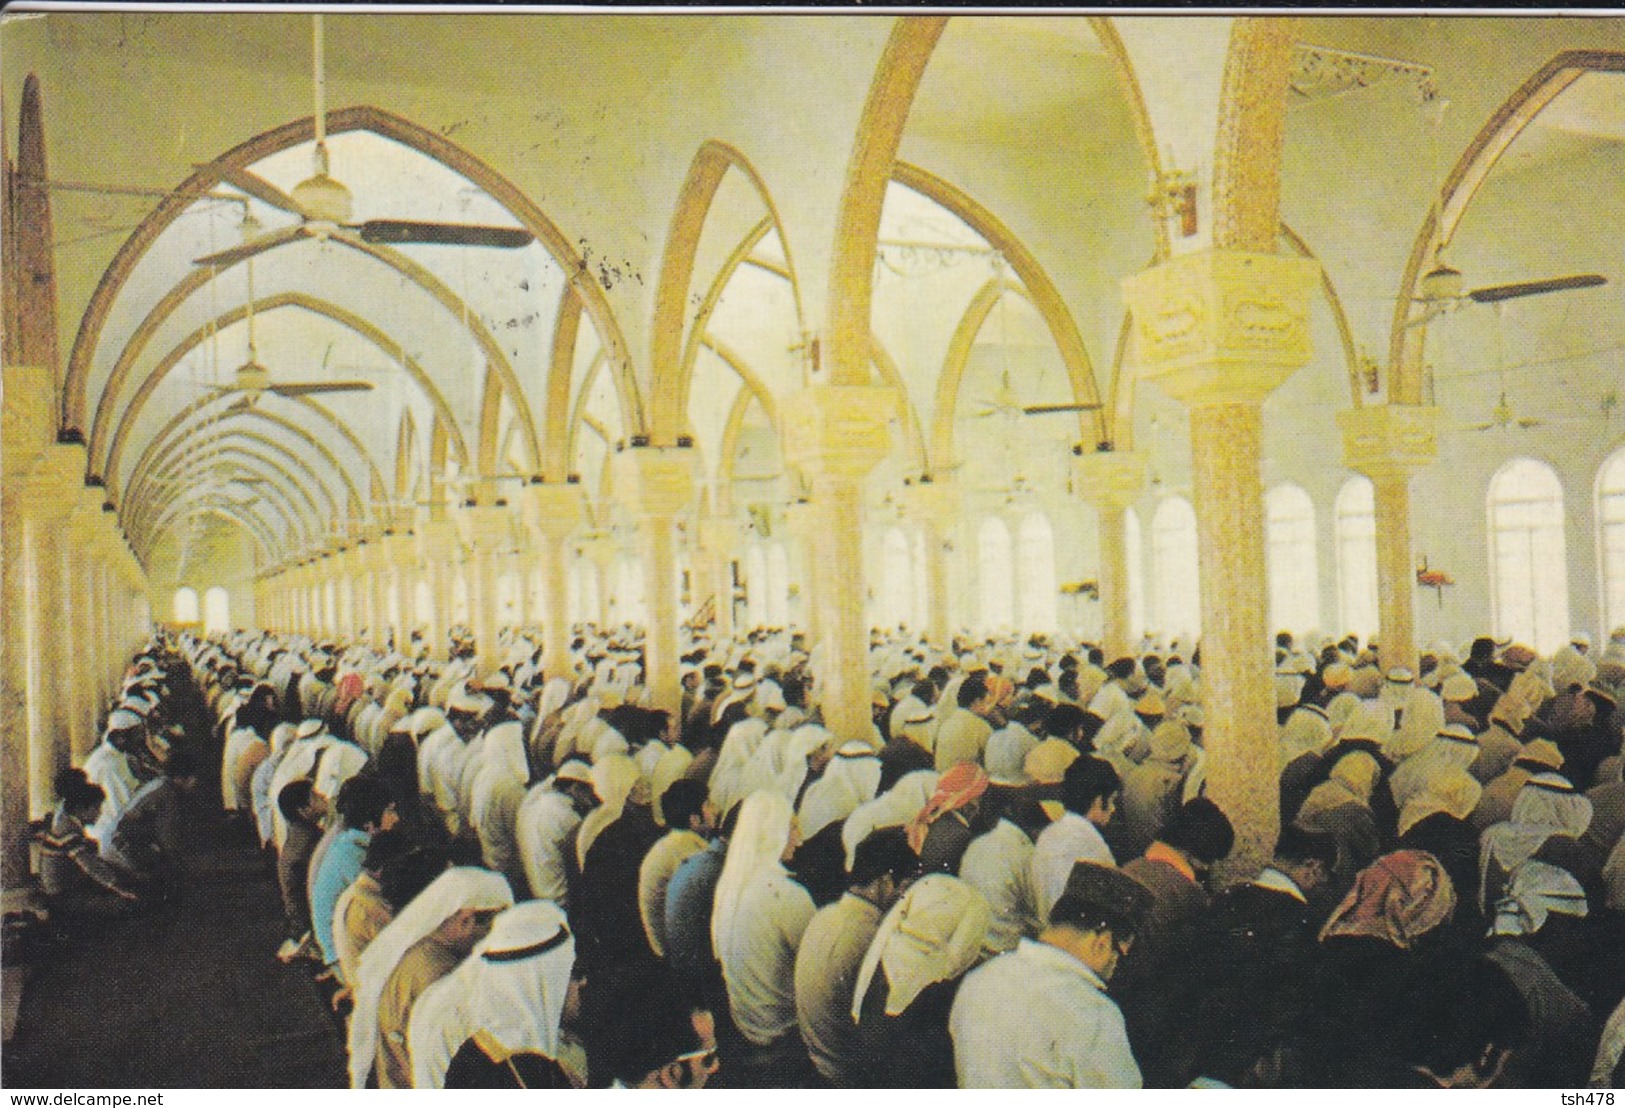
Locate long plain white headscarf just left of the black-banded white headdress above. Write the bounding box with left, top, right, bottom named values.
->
left=349, top=866, right=514, bottom=1089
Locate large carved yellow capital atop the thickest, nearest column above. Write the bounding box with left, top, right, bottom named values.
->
left=1123, top=250, right=1320, bottom=406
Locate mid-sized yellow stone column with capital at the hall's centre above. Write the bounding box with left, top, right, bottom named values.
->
left=780, top=385, right=899, bottom=741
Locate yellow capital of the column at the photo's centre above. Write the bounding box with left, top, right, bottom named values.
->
left=778, top=385, right=902, bottom=481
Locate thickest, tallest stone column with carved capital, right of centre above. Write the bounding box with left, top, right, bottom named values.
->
left=1123, top=250, right=1320, bottom=879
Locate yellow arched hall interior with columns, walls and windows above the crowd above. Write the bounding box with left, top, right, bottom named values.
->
left=0, top=11, right=1625, bottom=882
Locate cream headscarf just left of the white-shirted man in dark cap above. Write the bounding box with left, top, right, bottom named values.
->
left=852, top=874, right=993, bottom=1022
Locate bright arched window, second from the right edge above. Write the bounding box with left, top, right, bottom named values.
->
left=1489, top=458, right=1568, bottom=653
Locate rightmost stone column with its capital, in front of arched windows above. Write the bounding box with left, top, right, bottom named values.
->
left=1337, top=405, right=1438, bottom=671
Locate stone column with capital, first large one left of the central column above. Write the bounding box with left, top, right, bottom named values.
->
left=609, top=447, right=694, bottom=713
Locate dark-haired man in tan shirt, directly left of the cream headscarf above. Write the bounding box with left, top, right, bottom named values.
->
left=795, top=827, right=918, bottom=1089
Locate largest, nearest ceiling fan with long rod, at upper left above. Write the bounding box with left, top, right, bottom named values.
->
left=195, top=15, right=535, bottom=266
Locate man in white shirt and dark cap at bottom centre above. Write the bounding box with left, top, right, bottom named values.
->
left=949, top=863, right=1152, bottom=1089
